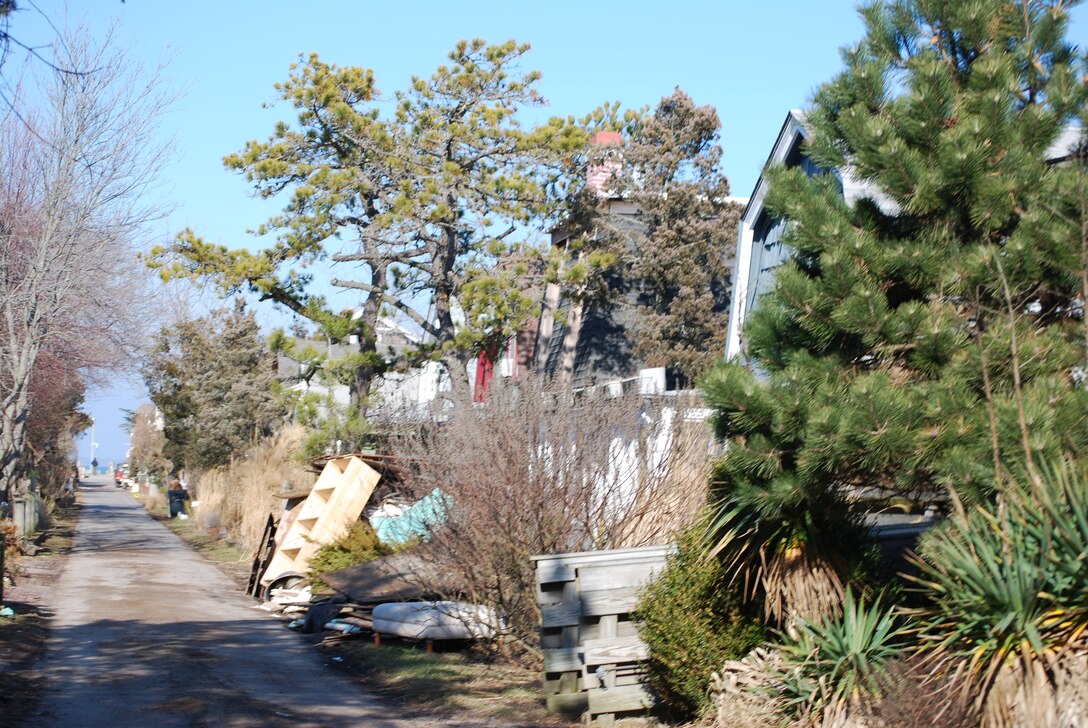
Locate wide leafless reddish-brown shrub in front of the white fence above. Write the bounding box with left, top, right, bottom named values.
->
left=390, top=378, right=710, bottom=654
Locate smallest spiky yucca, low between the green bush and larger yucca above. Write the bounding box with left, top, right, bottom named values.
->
left=779, top=589, right=911, bottom=716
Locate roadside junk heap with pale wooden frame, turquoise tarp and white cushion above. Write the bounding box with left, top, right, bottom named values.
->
left=247, top=455, right=496, bottom=645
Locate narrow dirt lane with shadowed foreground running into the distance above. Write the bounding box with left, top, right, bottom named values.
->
left=21, top=478, right=467, bottom=728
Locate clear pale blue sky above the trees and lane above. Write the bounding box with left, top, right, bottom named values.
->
left=5, top=0, right=1088, bottom=464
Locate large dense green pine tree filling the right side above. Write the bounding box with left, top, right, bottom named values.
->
left=705, top=0, right=1088, bottom=618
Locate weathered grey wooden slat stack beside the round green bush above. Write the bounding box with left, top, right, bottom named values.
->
left=533, top=546, right=672, bottom=728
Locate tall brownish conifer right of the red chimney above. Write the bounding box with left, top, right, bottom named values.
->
left=625, top=88, right=740, bottom=382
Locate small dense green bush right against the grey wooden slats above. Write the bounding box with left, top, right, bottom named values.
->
left=633, top=521, right=765, bottom=718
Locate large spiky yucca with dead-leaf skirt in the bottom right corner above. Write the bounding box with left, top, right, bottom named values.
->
left=914, top=465, right=1088, bottom=726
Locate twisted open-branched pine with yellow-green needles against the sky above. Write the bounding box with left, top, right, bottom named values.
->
left=151, top=39, right=585, bottom=412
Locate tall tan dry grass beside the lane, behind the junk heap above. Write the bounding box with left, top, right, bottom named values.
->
left=190, top=428, right=313, bottom=552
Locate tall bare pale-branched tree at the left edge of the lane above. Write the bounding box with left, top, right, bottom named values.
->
left=0, top=29, right=165, bottom=497
